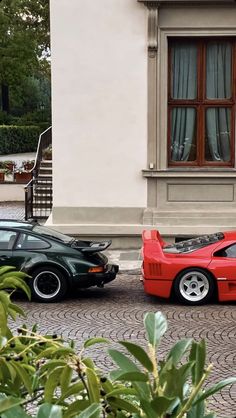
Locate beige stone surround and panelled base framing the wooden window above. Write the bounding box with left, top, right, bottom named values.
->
left=143, top=5, right=236, bottom=236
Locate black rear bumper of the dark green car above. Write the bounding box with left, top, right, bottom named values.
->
left=74, top=264, right=119, bottom=288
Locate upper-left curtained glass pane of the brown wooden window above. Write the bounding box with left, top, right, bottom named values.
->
left=171, top=41, right=197, bottom=99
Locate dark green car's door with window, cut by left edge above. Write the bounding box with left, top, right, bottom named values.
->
left=0, top=228, right=18, bottom=267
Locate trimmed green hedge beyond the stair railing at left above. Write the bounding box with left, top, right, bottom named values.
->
left=0, top=125, right=42, bottom=155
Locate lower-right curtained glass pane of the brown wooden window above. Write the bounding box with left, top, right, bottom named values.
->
left=205, top=107, right=231, bottom=162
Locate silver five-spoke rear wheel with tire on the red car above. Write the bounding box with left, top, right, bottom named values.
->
left=174, top=267, right=215, bottom=305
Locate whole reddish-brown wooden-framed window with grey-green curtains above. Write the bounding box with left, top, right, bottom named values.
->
left=168, top=38, right=236, bottom=167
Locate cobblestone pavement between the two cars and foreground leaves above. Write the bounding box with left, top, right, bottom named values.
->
left=13, top=274, right=236, bottom=418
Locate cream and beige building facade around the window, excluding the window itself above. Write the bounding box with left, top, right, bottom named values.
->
left=49, top=0, right=236, bottom=245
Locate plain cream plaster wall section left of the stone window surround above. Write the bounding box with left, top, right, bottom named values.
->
left=51, top=0, right=147, bottom=240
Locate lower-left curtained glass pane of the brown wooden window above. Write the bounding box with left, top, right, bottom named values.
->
left=171, top=107, right=197, bottom=161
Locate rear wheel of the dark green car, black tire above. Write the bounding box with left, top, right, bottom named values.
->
left=29, top=266, right=67, bottom=303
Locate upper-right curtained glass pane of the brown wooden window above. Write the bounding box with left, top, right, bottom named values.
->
left=206, top=41, right=232, bottom=99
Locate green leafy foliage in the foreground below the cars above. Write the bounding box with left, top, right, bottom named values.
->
left=0, top=267, right=236, bottom=418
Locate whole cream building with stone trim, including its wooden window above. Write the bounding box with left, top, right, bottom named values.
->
left=50, top=0, right=236, bottom=246
